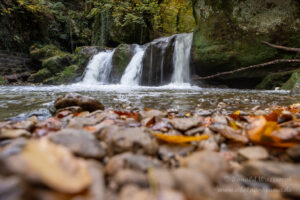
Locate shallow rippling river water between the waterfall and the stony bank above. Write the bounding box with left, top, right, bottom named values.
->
left=0, top=84, right=299, bottom=121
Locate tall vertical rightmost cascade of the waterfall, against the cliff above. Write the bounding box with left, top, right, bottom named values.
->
left=172, top=33, right=193, bottom=84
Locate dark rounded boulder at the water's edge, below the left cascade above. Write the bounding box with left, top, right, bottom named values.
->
left=54, top=93, right=104, bottom=112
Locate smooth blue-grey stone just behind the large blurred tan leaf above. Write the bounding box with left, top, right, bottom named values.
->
left=49, top=129, right=106, bottom=159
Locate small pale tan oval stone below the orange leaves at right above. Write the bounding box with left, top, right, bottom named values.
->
left=238, top=146, right=269, bottom=160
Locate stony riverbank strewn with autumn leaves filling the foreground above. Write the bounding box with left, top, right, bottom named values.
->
left=0, top=94, right=300, bottom=200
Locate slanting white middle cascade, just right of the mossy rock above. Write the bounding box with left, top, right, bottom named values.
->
left=121, top=45, right=145, bottom=86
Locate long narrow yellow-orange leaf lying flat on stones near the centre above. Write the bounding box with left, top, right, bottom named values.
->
left=152, top=133, right=209, bottom=144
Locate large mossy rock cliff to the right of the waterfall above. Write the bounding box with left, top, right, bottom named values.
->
left=192, top=0, right=300, bottom=87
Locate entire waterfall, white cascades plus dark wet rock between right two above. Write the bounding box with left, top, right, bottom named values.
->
left=82, top=33, right=193, bottom=86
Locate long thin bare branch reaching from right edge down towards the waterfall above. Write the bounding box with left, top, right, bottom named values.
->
left=197, top=59, right=300, bottom=80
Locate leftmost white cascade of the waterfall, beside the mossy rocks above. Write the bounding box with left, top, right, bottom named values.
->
left=82, top=50, right=115, bottom=84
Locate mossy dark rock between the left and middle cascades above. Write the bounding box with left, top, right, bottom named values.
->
left=110, top=44, right=134, bottom=83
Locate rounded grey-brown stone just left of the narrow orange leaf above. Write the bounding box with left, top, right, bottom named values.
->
left=99, top=126, right=158, bottom=155
